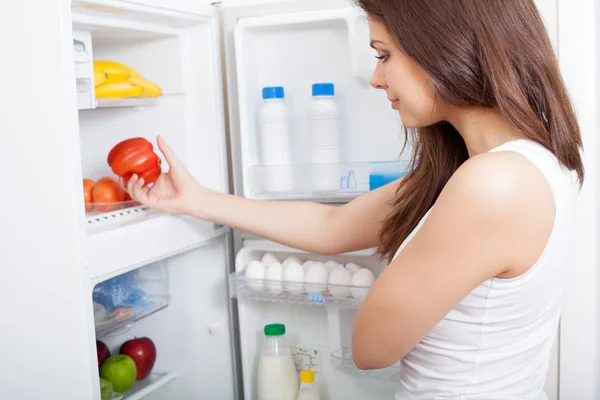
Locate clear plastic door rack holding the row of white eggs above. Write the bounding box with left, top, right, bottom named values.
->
left=229, top=271, right=370, bottom=309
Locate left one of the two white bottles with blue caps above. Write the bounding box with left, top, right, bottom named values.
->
left=258, top=86, right=294, bottom=193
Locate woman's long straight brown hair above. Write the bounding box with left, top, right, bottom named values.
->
left=355, top=0, right=584, bottom=261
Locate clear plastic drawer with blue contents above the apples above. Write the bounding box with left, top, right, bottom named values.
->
left=92, top=263, right=169, bottom=338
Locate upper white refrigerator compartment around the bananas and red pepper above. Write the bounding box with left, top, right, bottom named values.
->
left=73, top=3, right=228, bottom=239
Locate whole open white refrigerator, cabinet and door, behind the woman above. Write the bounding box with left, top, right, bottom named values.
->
left=0, top=0, right=595, bottom=400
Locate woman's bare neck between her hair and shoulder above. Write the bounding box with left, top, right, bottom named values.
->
left=447, top=108, right=522, bottom=157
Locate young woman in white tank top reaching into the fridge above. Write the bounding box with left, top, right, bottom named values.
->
left=128, top=0, right=584, bottom=400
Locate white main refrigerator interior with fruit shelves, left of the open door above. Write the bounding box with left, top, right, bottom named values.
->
left=72, top=0, right=236, bottom=400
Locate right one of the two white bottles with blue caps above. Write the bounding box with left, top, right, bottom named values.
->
left=309, top=83, right=342, bottom=192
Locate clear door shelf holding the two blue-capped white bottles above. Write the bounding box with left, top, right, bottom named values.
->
left=249, top=161, right=409, bottom=199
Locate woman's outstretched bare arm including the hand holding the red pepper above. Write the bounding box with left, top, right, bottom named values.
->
left=127, top=136, right=400, bottom=255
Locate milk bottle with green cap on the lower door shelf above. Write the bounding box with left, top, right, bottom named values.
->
left=257, top=324, right=299, bottom=400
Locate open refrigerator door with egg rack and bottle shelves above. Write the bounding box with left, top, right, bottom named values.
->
left=222, top=0, right=410, bottom=399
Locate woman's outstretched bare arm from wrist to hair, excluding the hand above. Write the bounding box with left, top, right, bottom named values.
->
left=197, top=180, right=400, bottom=255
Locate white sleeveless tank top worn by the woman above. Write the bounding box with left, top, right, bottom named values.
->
left=396, top=140, right=579, bottom=400
